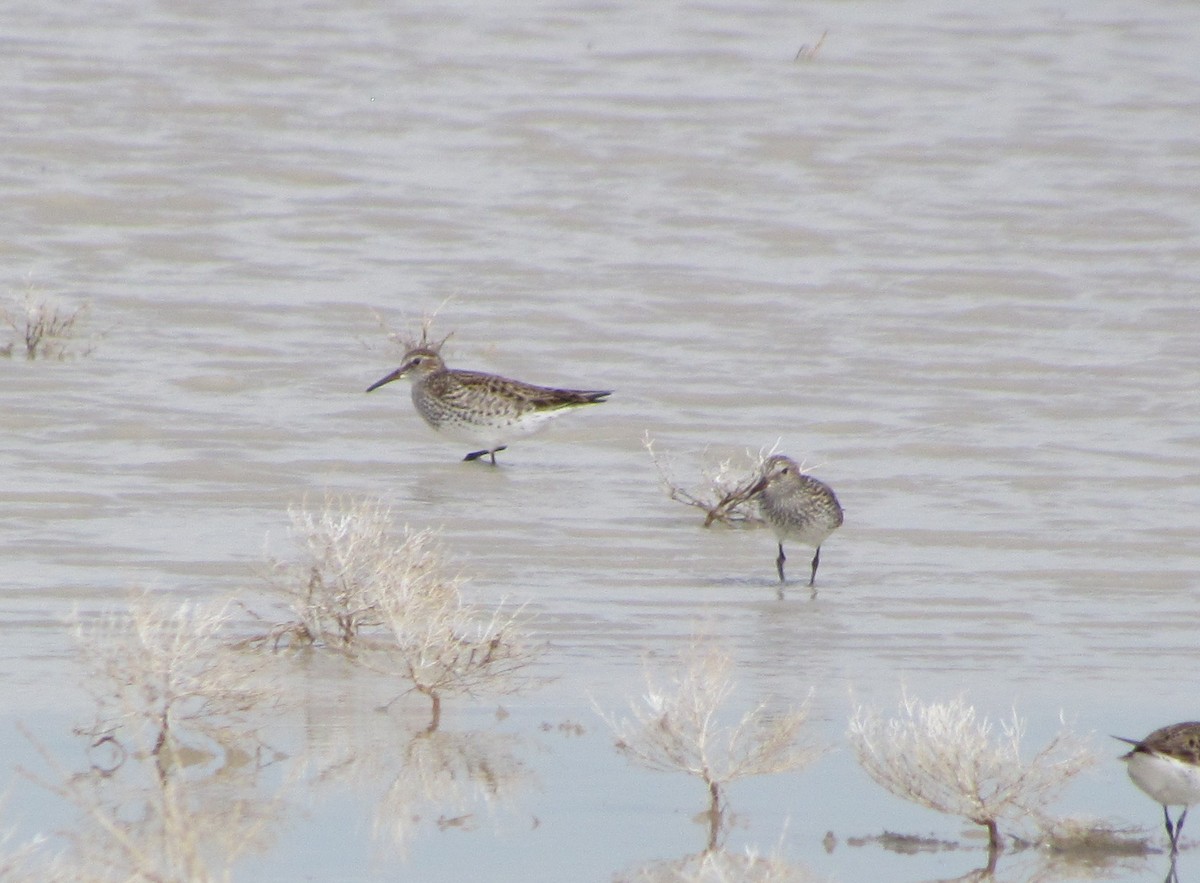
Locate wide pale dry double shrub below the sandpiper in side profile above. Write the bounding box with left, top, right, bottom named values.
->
left=265, top=499, right=536, bottom=731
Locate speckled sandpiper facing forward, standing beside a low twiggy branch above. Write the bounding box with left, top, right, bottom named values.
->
left=745, top=453, right=842, bottom=597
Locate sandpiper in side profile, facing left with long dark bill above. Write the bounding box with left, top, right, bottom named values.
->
left=367, top=346, right=612, bottom=464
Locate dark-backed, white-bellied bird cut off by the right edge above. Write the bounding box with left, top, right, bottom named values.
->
left=1114, top=721, right=1200, bottom=855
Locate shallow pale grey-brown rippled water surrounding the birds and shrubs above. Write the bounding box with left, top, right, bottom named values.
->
left=0, top=1, right=1200, bottom=881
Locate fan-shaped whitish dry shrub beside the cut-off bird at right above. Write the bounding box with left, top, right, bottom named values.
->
left=848, top=695, right=1096, bottom=859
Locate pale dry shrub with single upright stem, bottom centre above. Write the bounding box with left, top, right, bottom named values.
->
left=601, top=641, right=821, bottom=849
